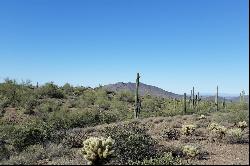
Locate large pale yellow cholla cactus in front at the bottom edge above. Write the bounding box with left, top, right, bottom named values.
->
left=82, top=137, right=115, bottom=165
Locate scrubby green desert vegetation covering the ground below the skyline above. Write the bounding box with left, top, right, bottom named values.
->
left=0, top=79, right=249, bottom=165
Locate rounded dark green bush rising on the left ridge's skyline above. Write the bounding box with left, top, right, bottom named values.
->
left=38, top=82, right=64, bottom=99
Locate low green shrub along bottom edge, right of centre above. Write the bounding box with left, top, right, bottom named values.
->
left=129, top=152, right=182, bottom=165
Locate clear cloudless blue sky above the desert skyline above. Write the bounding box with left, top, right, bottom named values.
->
left=0, top=0, right=249, bottom=94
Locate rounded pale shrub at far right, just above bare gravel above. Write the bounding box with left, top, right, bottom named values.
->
left=226, top=128, right=243, bottom=143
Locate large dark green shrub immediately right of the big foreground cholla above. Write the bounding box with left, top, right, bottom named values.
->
left=104, top=122, right=156, bottom=164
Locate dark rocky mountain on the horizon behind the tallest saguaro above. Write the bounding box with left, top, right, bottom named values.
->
left=103, top=82, right=182, bottom=98
